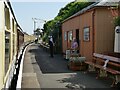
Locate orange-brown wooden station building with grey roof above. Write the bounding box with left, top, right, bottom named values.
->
left=62, top=3, right=118, bottom=60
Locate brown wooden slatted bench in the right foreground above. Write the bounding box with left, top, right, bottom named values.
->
left=85, top=53, right=120, bottom=86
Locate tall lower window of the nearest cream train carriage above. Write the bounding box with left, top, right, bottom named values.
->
left=5, top=31, right=10, bottom=73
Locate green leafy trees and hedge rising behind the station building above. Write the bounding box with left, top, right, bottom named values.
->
left=43, top=1, right=93, bottom=51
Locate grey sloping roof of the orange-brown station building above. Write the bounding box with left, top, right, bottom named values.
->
left=62, top=0, right=120, bottom=23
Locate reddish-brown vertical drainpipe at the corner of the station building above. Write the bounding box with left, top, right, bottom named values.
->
left=92, top=9, right=95, bottom=53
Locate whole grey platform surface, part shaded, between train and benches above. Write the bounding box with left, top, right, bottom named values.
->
left=22, top=44, right=112, bottom=90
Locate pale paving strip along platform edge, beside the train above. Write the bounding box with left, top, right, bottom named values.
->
left=21, top=46, right=40, bottom=88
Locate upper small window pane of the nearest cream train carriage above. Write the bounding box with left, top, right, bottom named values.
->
left=5, top=5, right=10, bottom=30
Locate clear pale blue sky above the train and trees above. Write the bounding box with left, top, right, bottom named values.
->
left=11, top=0, right=74, bottom=34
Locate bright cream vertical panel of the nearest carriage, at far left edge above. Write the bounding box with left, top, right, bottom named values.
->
left=0, top=1, right=5, bottom=90
